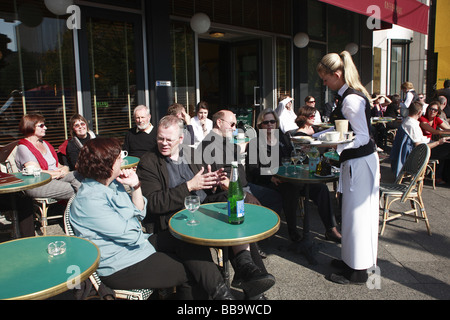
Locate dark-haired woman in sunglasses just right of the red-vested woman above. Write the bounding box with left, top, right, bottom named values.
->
left=67, top=114, right=95, bottom=171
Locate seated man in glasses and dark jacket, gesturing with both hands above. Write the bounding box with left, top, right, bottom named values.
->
left=137, top=116, right=275, bottom=297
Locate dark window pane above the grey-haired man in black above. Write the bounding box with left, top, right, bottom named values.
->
left=86, top=18, right=137, bottom=138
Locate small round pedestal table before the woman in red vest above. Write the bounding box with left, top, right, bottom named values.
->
left=0, top=172, right=52, bottom=238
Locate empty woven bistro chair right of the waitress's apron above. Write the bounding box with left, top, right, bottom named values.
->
left=380, top=144, right=431, bottom=235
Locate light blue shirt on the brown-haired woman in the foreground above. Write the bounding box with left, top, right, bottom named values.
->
left=70, top=179, right=155, bottom=276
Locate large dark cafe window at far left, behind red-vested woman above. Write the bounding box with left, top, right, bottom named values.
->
left=0, top=0, right=77, bottom=148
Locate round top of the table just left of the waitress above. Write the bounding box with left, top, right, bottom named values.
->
left=275, top=164, right=339, bottom=183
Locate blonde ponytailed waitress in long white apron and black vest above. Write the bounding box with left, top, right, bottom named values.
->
left=317, top=51, right=380, bottom=284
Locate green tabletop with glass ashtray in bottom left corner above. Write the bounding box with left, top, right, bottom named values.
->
left=0, top=236, right=100, bottom=300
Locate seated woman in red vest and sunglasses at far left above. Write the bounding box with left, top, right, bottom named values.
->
left=15, top=114, right=80, bottom=200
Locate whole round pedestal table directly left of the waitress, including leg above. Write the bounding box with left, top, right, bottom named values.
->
left=275, top=164, right=339, bottom=264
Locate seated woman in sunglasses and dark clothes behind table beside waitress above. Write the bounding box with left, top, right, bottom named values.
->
left=246, top=107, right=341, bottom=242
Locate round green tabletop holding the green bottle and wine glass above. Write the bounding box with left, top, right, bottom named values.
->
left=169, top=202, right=280, bottom=247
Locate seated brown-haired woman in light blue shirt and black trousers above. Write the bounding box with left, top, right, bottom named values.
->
left=70, top=138, right=233, bottom=299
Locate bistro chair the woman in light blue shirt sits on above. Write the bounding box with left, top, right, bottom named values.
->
left=64, top=196, right=153, bottom=300
